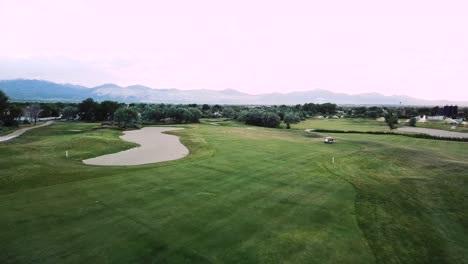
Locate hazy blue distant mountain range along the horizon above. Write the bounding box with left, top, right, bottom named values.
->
left=0, top=79, right=468, bottom=106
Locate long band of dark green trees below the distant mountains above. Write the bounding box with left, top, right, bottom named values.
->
left=0, top=88, right=468, bottom=129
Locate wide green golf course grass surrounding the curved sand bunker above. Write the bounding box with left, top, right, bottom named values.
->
left=0, top=120, right=468, bottom=263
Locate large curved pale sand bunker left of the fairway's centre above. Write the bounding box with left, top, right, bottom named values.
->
left=83, top=127, right=189, bottom=166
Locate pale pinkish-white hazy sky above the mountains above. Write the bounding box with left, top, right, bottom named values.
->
left=0, top=0, right=468, bottom=100
